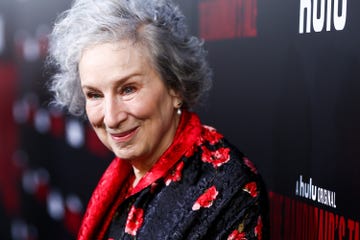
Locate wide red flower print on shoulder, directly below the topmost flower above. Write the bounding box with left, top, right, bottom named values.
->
left=201, top=146, right=230, bottom=168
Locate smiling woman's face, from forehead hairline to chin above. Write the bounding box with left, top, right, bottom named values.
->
left=79, top=41, right=180, bottom=164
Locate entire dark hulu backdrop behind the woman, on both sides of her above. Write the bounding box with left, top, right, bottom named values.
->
left=0, top=0, right=360, bottom=240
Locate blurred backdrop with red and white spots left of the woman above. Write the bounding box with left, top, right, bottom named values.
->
left=0, top=0, right=113, bottom=239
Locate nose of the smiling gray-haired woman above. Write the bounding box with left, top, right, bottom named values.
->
left=104, top=97, right=127, bottom=128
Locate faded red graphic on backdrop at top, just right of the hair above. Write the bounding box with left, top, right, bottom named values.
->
left=199, top=0, right=257, bottom=40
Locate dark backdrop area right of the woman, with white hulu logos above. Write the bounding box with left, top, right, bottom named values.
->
left=182, top=0, right=360, bottom=240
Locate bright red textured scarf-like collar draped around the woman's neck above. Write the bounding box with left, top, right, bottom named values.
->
left=78, top=111, right=201, bottom=240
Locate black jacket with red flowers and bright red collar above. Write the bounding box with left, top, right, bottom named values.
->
left=78, top=111, right=268, bottom=240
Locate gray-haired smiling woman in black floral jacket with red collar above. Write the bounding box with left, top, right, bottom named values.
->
left=48, top=0, right=267, bottom=240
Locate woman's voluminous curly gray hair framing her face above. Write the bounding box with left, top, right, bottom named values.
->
left=46, top=0, right=212, bottom=116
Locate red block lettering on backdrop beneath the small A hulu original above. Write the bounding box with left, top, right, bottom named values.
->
left=269, top=192, right=360, bottom=240
